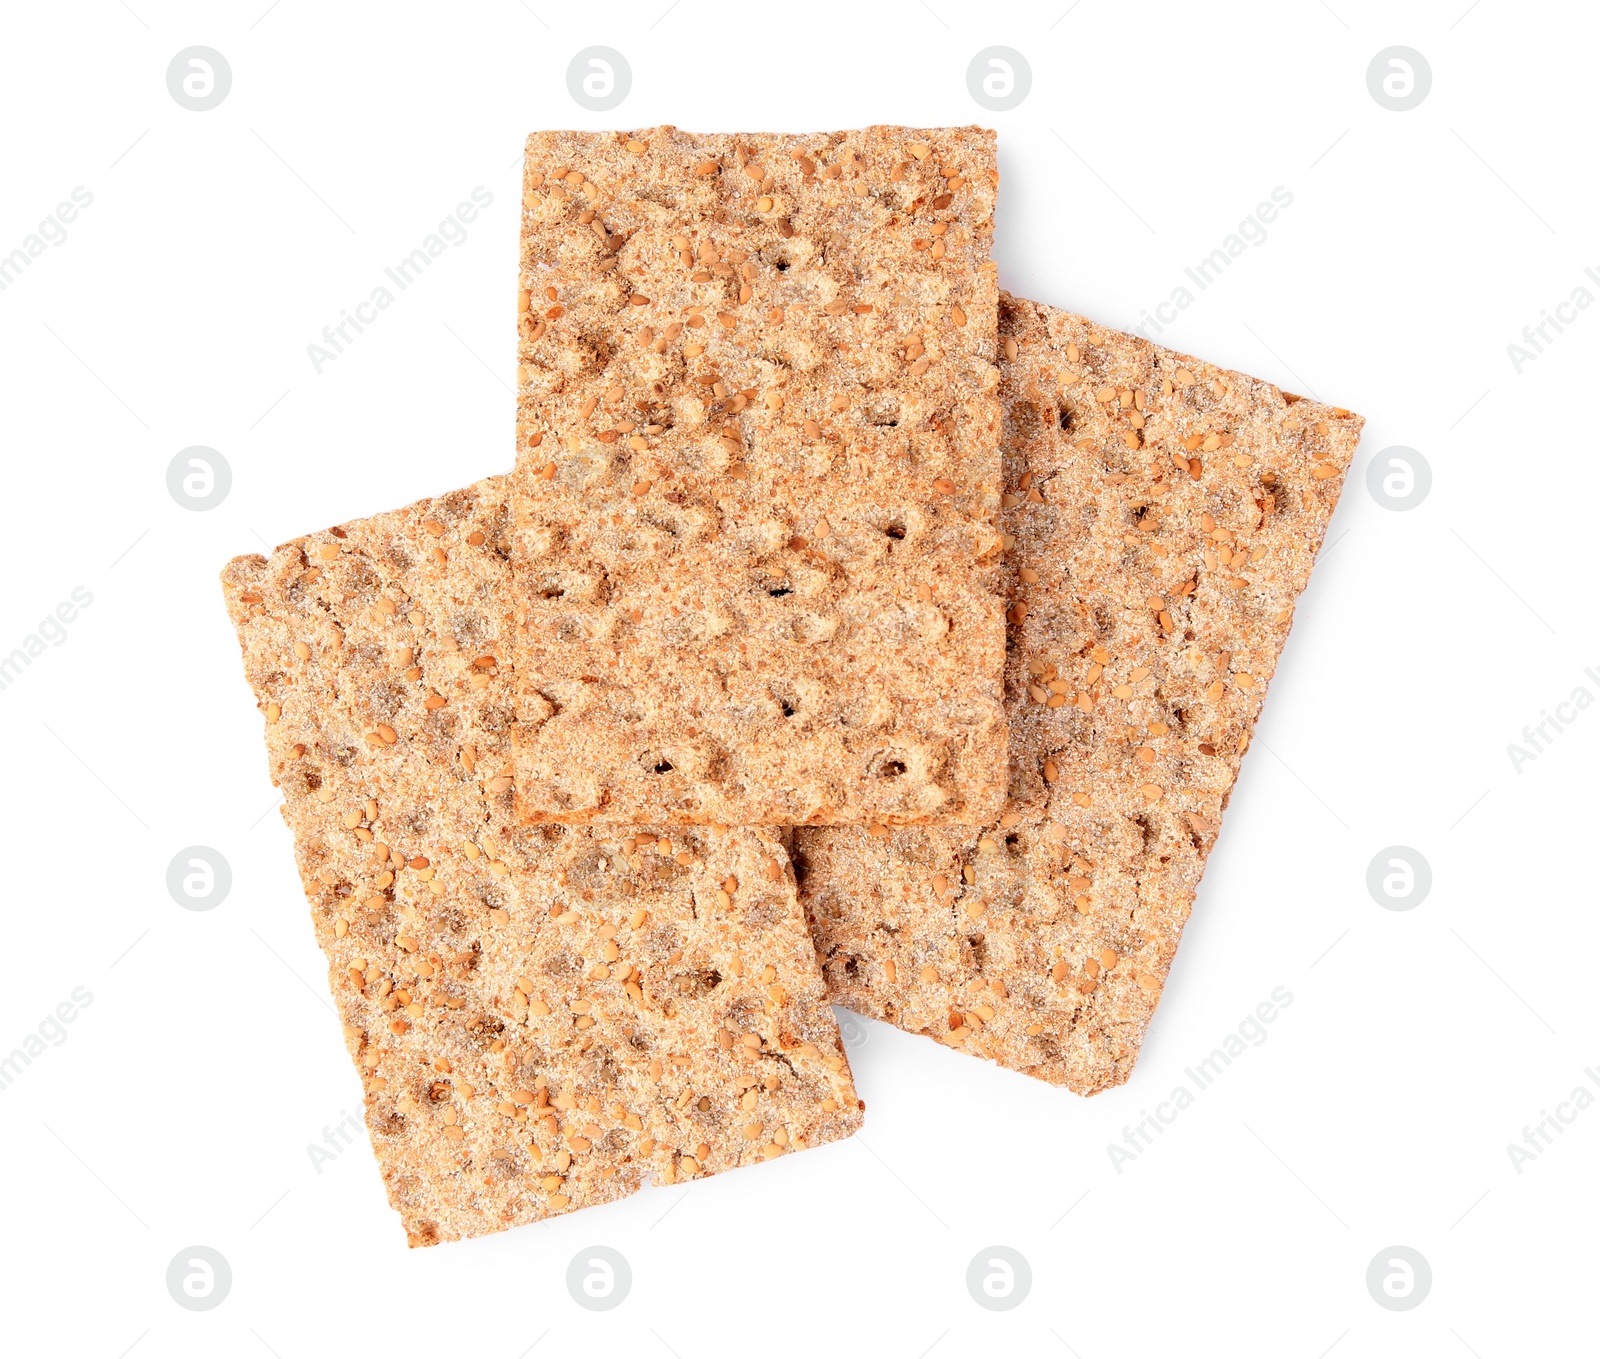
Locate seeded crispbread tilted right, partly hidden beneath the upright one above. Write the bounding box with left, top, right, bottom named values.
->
left=794, top=296, right=1362, bottom=1095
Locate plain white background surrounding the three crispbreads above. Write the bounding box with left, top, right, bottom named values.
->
left=0, top=0, right=1600, bottom=1359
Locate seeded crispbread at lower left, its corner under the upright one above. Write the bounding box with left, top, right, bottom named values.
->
left=222, top=479, right=861, bottom=1245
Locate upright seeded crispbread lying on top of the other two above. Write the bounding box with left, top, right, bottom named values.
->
left=512, top=126, right=1006, bottom=826
